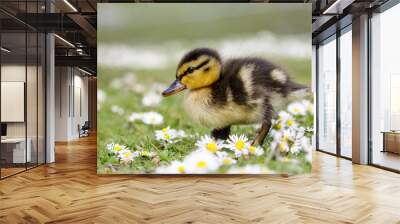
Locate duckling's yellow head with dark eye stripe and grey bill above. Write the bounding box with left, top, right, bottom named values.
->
left=162, top=48, right=222, bottom=96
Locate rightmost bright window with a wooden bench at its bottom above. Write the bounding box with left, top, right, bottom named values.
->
left=370, top=4, right=400, bottom=170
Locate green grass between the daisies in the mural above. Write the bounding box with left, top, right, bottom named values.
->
left=97, top=60, right=311, bottom=174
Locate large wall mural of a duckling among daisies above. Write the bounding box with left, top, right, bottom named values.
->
left=97, top=4, right=314, bottom=174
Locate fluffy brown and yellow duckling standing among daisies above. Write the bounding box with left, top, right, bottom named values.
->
left=162, top=48, right=307, bottom=145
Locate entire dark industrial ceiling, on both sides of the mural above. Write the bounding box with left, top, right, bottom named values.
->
left=0, top=0, right=394, bottom=73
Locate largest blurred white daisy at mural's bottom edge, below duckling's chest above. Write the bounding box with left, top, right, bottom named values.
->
left=183, top=150, right=219, bottom=174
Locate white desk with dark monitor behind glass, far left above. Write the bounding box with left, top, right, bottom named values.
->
left=1, top=138, right=32, bottom=163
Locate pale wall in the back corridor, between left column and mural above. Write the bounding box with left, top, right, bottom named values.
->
left=55, top=67, right=88, bottom=141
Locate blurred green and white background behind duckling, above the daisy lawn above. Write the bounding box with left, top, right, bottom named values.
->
left=98, top=3, right=311, bottom=84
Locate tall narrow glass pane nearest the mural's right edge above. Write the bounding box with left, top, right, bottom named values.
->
left=317, top=36, right=336, bottom=154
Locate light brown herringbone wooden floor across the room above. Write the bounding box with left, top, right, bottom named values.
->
left=0, top=137, right=400, bottom=224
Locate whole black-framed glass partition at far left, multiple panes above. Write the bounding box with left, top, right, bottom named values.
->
left=0, top=1, right=46, bottom=179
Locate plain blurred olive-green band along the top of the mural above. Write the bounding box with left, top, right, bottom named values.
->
left=98, top=3, right=311, bottom=44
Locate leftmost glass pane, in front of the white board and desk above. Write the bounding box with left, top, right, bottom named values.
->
left=0, top=32, right=27, bottom=177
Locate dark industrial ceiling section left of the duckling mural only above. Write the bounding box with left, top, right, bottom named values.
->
left=0, top=0, right=97, bottom=74
